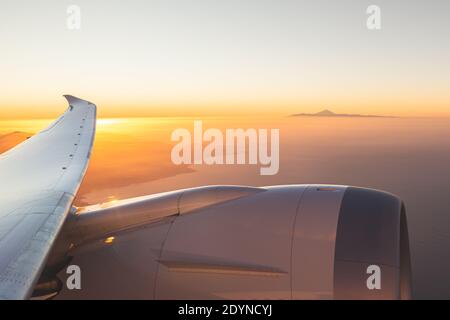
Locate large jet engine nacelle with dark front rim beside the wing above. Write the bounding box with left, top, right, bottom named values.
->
left=49, top=185, right=411, bottom=299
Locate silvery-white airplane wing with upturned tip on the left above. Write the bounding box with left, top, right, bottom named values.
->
left=0, top=95, right=96, bottom=299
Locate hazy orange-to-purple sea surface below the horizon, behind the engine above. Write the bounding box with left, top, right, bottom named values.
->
left=0, top=117, right=450, bottom=299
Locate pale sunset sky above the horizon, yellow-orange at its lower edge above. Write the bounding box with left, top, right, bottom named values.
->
left=0, top=0, right=450, bottom=118
